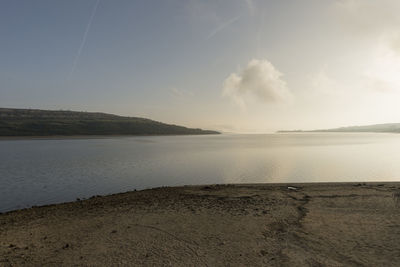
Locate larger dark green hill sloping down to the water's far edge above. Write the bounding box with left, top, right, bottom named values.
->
left=0, top=108, right=219, bottom=136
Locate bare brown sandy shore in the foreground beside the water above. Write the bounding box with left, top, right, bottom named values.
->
left=0, top=183, right=400, bottom=266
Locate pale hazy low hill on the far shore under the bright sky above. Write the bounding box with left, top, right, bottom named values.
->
left=279, top=123, right=400, bottom=133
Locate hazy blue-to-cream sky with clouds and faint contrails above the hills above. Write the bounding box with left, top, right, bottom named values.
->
left=0, top=0, right=400, bottom=133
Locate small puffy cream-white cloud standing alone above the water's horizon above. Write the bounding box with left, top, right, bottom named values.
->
left=222, top=59, right=292, bottom=107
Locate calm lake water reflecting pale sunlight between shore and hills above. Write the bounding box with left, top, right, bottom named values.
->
left=0, top=133, right=400, bottom=212
